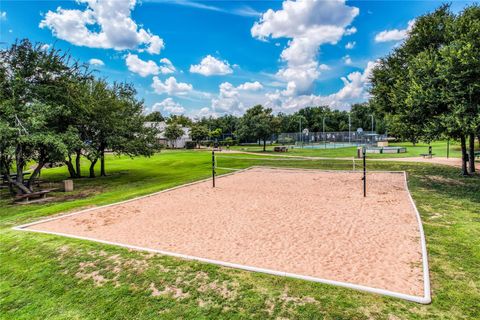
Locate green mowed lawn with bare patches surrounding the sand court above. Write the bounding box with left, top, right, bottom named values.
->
left=0, top=151, right=480, bottom=320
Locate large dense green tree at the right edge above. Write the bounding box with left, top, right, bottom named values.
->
left=372, top=5, right=480, bottom=174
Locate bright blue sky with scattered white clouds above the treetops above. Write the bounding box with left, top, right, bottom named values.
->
left=0, top=0, right=468, bottom=117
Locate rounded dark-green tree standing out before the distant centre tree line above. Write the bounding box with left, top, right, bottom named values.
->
left=237, top=105, right=280, bottom=151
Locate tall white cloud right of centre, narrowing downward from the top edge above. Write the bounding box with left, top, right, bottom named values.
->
left=251, top=0, right=359, bottom=94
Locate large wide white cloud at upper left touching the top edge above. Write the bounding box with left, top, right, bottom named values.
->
left=39, top=0, right=164, bottom=54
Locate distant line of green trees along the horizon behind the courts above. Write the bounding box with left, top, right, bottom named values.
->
left=157, top=103, right=387, bottom=152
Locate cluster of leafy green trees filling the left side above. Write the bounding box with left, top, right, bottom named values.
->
left=0, top=40, right=161, bottom=193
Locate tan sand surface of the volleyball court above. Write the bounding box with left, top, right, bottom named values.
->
left=17, top=168, right=430, bottom=303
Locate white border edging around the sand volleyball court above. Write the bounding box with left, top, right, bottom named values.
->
left=12, top=166, right=431, bottom=304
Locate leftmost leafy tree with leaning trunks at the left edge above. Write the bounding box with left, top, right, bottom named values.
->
left=0, top=40, right=81, bottom=193
